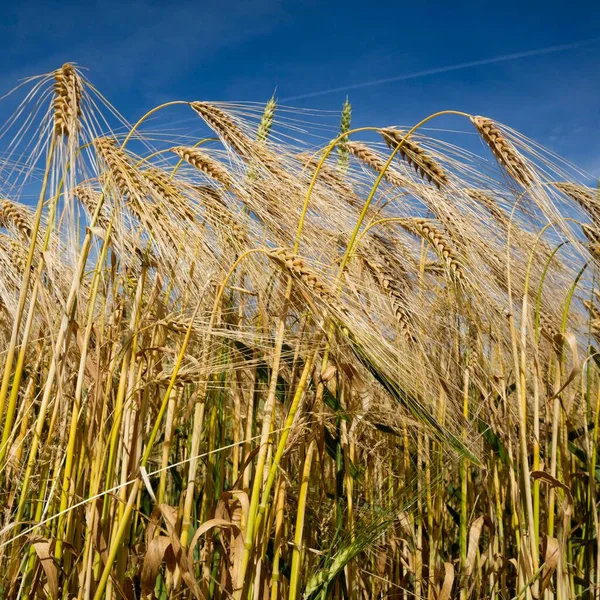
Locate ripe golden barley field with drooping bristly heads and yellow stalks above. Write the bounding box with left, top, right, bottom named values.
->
left=0, top=64, right=600, bottom=600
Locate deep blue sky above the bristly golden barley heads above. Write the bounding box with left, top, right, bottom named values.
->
left=0, top=0, right=600, bottom=176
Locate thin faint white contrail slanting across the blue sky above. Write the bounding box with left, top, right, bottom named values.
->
left=281, top=37, right=600, bottom=102
